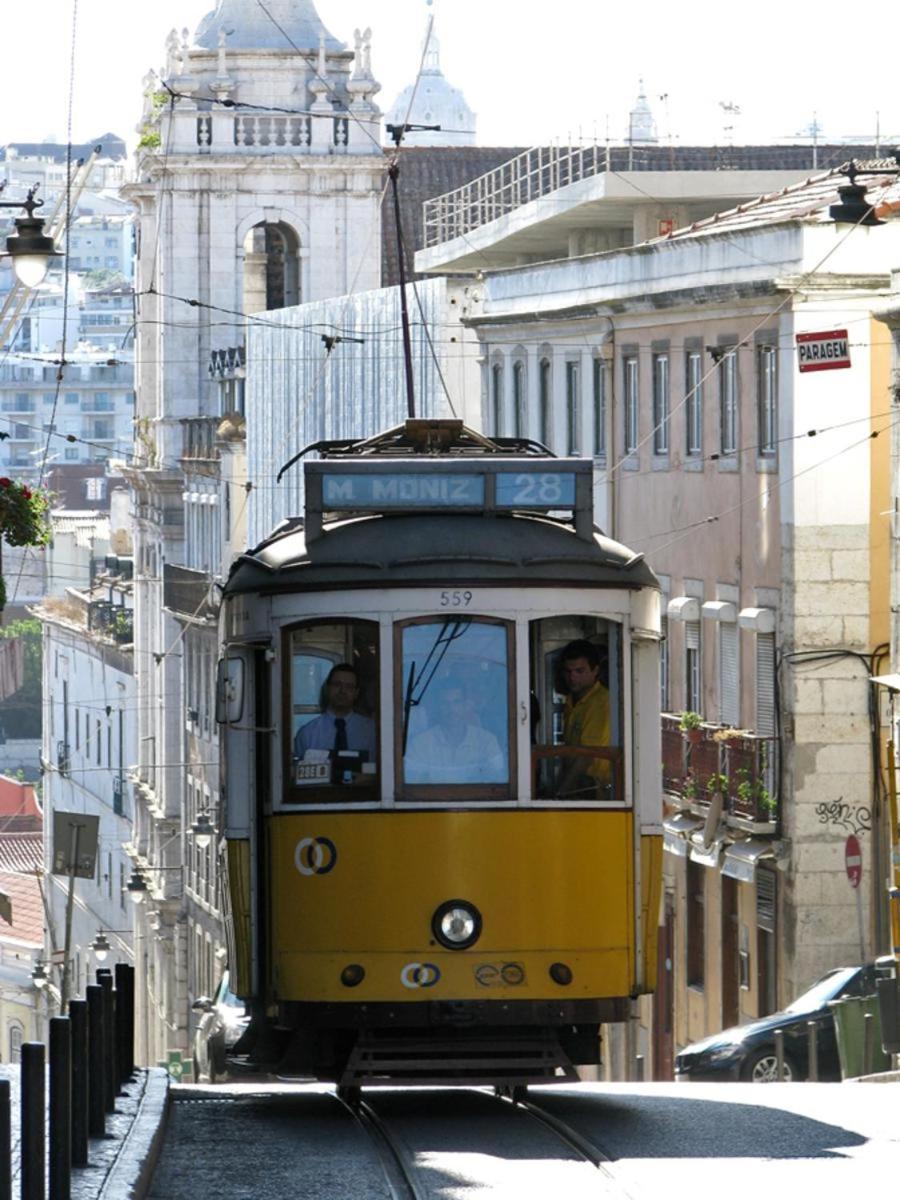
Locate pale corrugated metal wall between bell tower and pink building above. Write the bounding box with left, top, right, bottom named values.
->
left=246, top=280, right=450, bottom=545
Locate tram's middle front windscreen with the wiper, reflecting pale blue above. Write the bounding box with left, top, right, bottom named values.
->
left=395, top=618, right=515, bottom=800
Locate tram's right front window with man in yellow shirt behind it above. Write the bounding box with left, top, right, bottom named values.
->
left=530, top=617, right=624, bottom=804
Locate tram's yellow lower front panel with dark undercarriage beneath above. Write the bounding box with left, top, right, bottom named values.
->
left=229, top=810, right=661, bottom=1087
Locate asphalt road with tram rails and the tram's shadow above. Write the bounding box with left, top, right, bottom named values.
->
left=149, top=1084, right=900, bottom=1200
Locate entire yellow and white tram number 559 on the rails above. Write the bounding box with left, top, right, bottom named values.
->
left=218, top=421, right=661, bottom=1091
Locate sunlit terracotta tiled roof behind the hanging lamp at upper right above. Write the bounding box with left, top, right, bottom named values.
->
left=654, top=158, right=900, bottom=241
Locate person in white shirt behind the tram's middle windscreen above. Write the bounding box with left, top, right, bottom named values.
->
left=403, top=684, right=509, bottom=784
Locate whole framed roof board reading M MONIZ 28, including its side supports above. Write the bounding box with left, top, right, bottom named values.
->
left=305, top=457, right=593, bottom=540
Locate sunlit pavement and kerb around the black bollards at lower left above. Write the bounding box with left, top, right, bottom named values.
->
left=0, top=1066, right=169, bottom=1200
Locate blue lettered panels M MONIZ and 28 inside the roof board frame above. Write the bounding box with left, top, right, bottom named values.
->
left=322, top=469, right=575, bottom=512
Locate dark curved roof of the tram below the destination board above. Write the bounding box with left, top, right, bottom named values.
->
left=226, top=512, right=659, bottom=595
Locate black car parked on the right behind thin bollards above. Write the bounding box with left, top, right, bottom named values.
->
left=676, top=964, right=876, bottom=1084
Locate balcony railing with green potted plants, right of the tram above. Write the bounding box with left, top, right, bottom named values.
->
left=662, top=713, right=779, bottom=833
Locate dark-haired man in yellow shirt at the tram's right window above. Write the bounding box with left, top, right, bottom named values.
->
left=559, top=640, right=612, bottom=799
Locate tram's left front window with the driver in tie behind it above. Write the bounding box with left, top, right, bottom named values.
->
left=284, top=620, right=378, bottom=804
